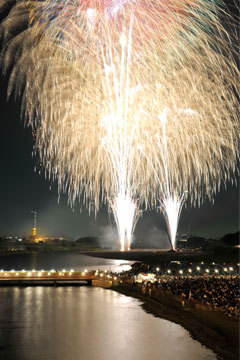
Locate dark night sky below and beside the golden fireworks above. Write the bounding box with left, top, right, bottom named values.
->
left=0, top=2, right=239, bottom=247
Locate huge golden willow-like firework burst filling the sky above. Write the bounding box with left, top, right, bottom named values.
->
left=1, top=0, right=239, bottom=247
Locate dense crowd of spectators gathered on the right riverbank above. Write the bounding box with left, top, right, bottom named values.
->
left=118, top=263, right=240, bottom=317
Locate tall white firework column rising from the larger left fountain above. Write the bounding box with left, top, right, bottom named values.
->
left=99, top=23, right=143, bottom=251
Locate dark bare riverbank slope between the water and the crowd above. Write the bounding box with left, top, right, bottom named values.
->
left=112, top=284, right=239, bottom=360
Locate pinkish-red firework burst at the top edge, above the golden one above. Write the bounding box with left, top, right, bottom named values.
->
left=29, top=0, right=206, bottom=48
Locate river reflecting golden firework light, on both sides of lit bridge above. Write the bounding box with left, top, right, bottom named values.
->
left=0, top=254, right=216, bottom=360
